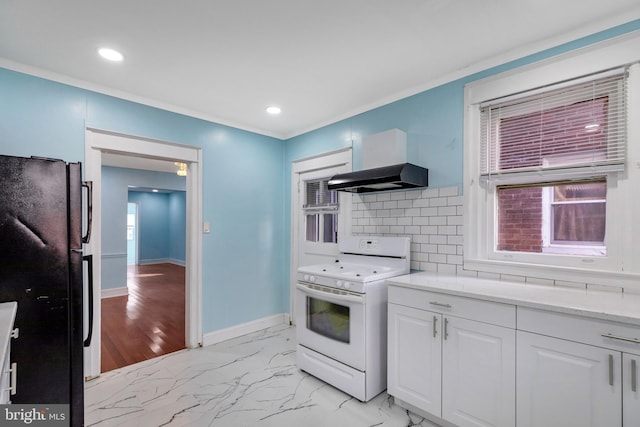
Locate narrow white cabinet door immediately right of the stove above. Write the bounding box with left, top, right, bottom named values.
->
left=387, top=304, right=442, bottom=416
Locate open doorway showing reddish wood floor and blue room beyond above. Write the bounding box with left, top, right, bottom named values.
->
left=100, top=186, right=186, bottom=373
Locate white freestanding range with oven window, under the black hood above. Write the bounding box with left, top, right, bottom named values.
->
left=295, top=236, right=410, bottom=402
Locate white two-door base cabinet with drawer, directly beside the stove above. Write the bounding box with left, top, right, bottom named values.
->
left=387, top=286, right=515, bottom=427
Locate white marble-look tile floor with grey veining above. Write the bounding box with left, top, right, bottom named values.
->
left=85, top=325, right=432, bottom=427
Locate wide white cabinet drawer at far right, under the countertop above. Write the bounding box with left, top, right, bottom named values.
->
left=517, top=307, right=640, bottom=355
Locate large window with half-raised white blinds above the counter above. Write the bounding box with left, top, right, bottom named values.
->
left=480, top=69, right=626, bottom=256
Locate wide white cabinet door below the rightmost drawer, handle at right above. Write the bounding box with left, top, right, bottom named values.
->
left=516, top=331, right=622, bottom=427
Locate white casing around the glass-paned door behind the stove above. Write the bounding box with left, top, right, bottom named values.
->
left=289, top=147, right=353, bottom=323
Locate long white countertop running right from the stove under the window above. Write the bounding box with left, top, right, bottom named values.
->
left=387, top=272, right=640, bottom=326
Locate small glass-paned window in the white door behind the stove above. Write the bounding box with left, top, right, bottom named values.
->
left=303, top=178, right=338, bottom=243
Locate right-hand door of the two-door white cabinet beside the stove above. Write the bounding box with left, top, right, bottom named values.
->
left=442, top=316, right=516, bottom=427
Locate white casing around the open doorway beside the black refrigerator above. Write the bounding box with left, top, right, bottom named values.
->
left=84, top=127, right=202, bottom=378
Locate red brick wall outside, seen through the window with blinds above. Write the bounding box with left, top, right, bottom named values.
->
left=496, top=97, right=608, bottom=252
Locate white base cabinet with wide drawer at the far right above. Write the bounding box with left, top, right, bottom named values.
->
left=516, top=307, right=640, bottom=427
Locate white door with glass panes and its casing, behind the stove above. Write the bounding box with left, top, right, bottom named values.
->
left=290, top=148, right=351, bottom=321
